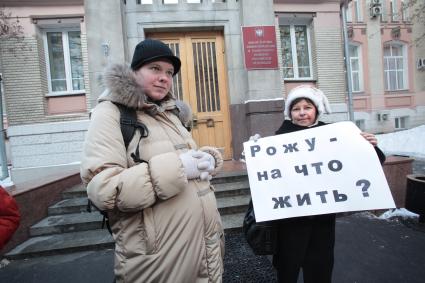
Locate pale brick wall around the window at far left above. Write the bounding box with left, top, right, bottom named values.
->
left=0, top=35, right=89, bottom=126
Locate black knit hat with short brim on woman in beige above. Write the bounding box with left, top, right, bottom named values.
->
left=131, top=38, right=181, bottom=76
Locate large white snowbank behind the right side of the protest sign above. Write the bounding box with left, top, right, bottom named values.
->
left=376, top=125, right=425, bottom=158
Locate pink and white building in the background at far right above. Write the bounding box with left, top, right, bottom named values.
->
left=347, top=0, right=425, bottom=133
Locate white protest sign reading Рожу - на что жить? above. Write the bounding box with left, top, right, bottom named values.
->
left=244, top=122, right=395, bottom=222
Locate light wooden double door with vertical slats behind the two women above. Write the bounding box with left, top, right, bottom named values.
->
left=147, top=32, right=232, bottom=159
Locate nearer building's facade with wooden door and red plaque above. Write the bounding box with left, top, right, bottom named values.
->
left=0, top=0, right=348, bottom=180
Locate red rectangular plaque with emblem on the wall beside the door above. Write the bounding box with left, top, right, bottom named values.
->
left=242, top=26, right=278, bottom=70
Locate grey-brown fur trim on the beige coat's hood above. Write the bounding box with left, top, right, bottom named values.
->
left=98, top=64, right=192, bottom=128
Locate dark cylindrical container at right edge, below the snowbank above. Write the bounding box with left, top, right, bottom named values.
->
left=406, top=174, right=425, bottom=223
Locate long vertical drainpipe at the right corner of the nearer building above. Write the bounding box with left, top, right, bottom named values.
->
left=341, top=0, right=354, bottom=122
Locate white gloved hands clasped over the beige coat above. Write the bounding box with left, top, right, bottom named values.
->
left=179, top=150, right=215, bottom=181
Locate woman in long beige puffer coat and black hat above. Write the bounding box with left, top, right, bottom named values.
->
left=81, top=39, right=224, bottom=283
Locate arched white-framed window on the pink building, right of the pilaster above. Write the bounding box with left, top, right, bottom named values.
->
left=384, top=43, right=407, bottom=91
